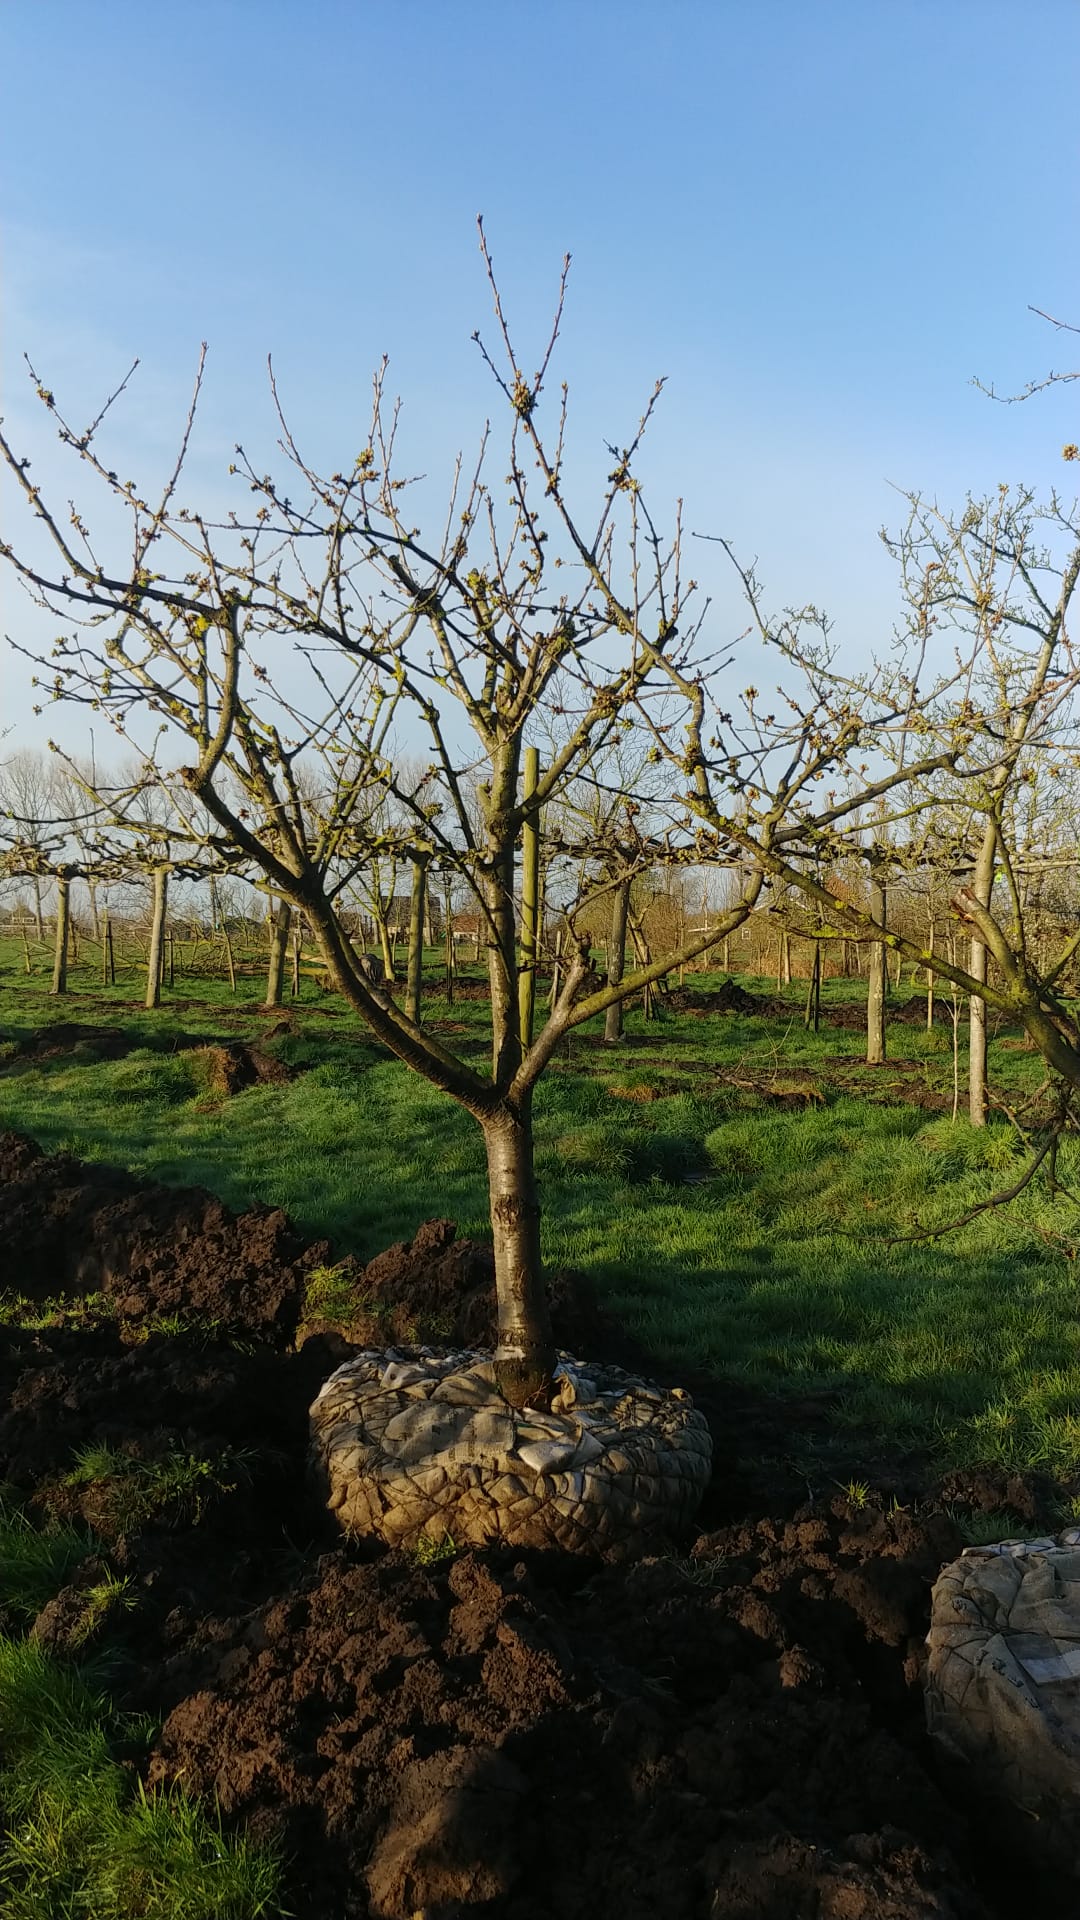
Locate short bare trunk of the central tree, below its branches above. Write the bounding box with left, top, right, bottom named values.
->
left=482, top=1094, right=555, bottom=1407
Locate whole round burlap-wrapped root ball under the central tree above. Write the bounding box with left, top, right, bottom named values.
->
left=311, top=1348, right=711, bottom=1553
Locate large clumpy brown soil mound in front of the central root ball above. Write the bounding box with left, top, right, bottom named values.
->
left=150, top=1509, right=986, bottom=1920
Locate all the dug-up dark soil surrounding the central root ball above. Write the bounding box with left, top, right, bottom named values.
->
left=0, top=1135, right=1070, bottom=1920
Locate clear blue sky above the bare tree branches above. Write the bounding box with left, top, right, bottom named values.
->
left=0, top=0, right=1080, bottom=743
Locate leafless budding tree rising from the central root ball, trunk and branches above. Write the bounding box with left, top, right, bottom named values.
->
left=0, top=246, right=1006, bottom=1405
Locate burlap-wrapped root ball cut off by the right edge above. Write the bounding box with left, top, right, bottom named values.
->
left=926, top=1528, right=1080, bottom=1876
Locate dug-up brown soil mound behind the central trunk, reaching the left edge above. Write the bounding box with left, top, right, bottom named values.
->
left=0, top=1128, right=600, bottom=1359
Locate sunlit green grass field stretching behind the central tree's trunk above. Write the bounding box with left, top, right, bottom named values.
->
left=0, top=945, right=1080, bottom=1490
